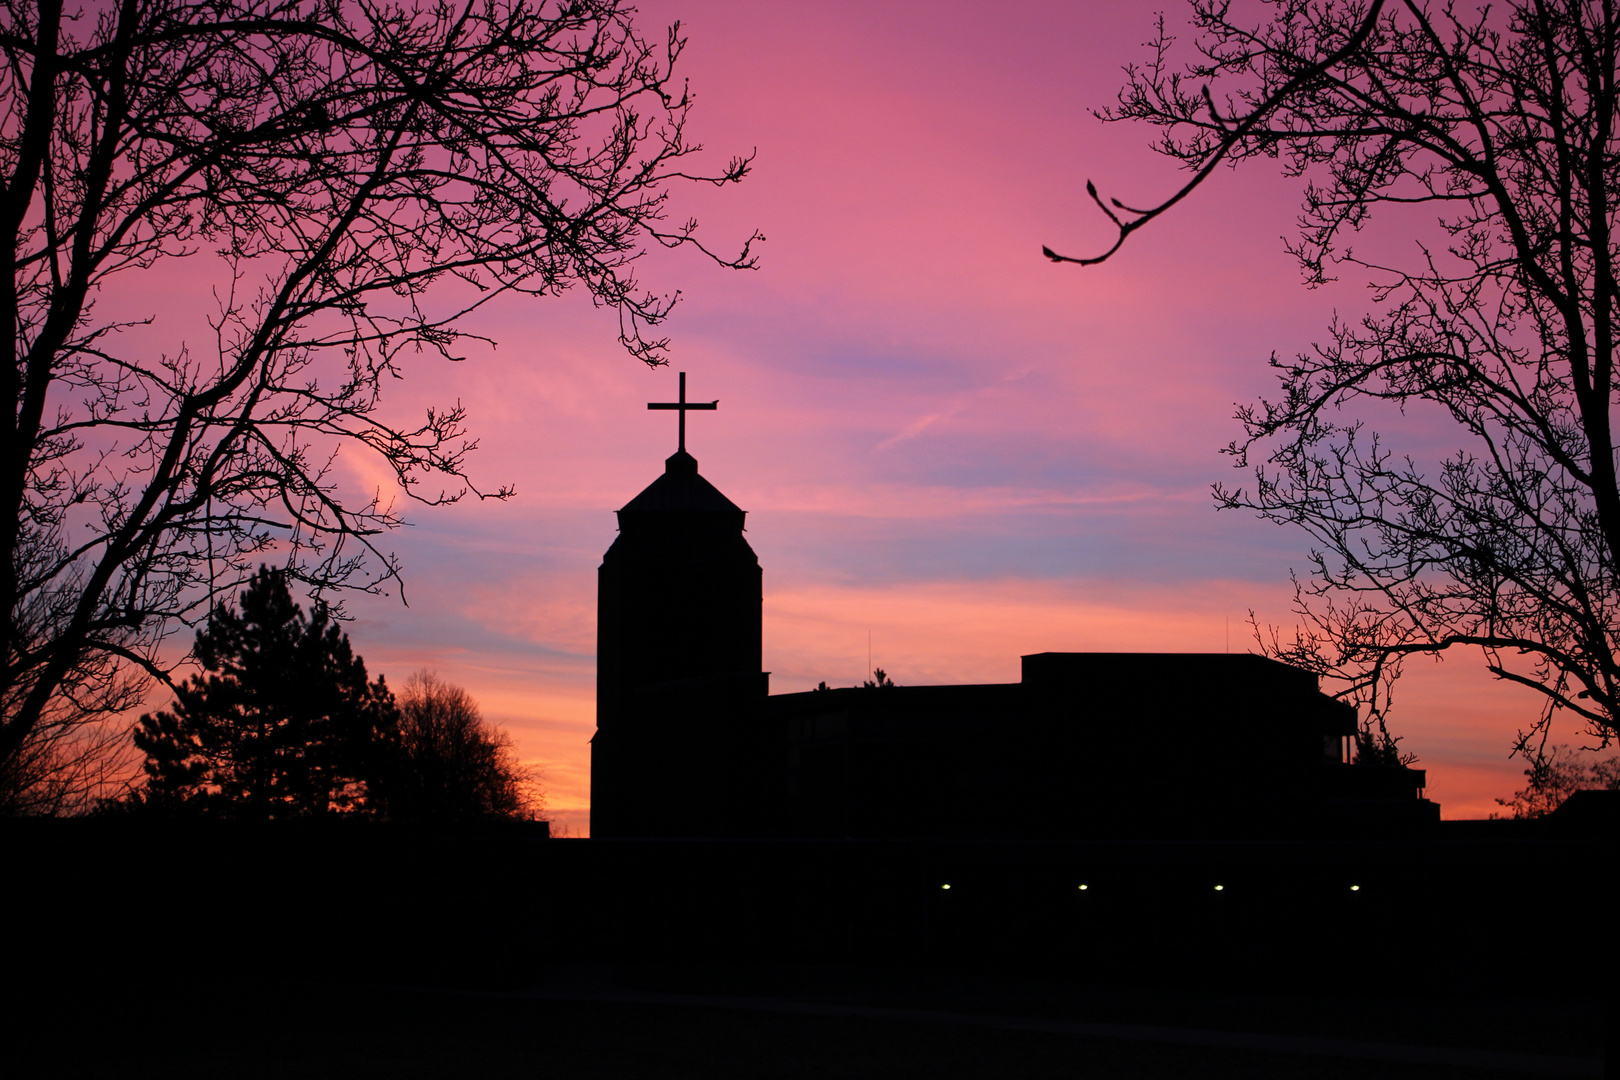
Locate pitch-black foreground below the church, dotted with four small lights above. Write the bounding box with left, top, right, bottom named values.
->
left=0, top=823, right=1620, bottom=1080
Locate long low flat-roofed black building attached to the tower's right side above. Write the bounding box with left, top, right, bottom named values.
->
left=761, top=653, right=1406, bottom=839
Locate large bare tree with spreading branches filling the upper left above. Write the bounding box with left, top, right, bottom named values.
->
left=0, top=0, right=753, bottom=809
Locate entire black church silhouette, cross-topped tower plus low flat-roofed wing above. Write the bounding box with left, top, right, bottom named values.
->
left=591, top=372, right=1439, bottom=840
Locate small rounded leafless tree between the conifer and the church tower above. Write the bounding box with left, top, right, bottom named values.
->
left=382, top=670, right=544, bottom=823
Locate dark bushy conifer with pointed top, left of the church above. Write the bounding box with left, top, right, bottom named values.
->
left=134, top=567, right=399, bottom=821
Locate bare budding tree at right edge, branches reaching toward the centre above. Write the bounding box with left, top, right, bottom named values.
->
left=1047, top=0, right=1620, bottom=761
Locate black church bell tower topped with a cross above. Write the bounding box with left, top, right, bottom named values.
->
left=591, top=372, right=766, bottom=837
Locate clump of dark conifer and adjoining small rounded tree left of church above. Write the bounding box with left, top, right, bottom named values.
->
left=115, top=567, right=543, bottom=824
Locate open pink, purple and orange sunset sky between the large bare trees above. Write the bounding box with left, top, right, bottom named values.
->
left=255, top=0, right=1573, bottom=836
